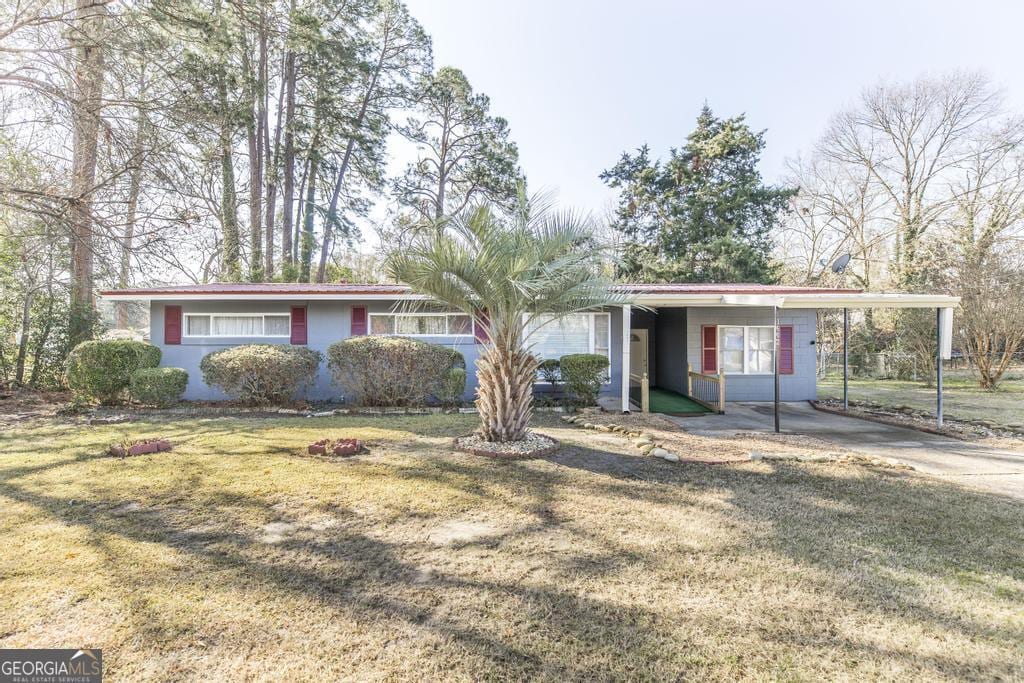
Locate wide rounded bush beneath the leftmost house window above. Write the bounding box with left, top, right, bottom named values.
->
left=199, top=344, right=324, bottom=403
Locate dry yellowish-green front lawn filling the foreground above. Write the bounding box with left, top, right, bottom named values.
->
left=0, top=416, right=1024, bottom=681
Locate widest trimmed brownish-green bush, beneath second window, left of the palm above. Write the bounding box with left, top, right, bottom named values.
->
left=327, top=336, right=466, bottom=407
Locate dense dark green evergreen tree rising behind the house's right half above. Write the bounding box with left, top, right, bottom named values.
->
left=601, top=104, right=796, bottom=283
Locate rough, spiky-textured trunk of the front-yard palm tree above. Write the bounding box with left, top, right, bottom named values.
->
left=476, top=344, right=538, bottom=442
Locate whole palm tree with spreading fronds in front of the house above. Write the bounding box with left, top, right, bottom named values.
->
left=387, top=200, right=625, bottom=441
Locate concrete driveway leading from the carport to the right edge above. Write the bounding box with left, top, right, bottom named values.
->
left=671, top=402, right=1024, bottom=500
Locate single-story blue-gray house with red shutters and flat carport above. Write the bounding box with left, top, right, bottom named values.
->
left=101, top=283, right=956, bottom=410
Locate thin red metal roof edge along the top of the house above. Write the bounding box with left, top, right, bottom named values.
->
left=100, top=283, right=861, bottom=297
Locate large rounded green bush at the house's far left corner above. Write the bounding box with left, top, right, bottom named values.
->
left=66, top=339, right=161, bottom=405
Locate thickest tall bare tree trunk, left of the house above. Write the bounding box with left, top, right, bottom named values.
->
left=69, top=0, right=106, bottom=346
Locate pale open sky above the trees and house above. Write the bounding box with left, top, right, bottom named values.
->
left=397, top=0, right=1024, bottom=213
